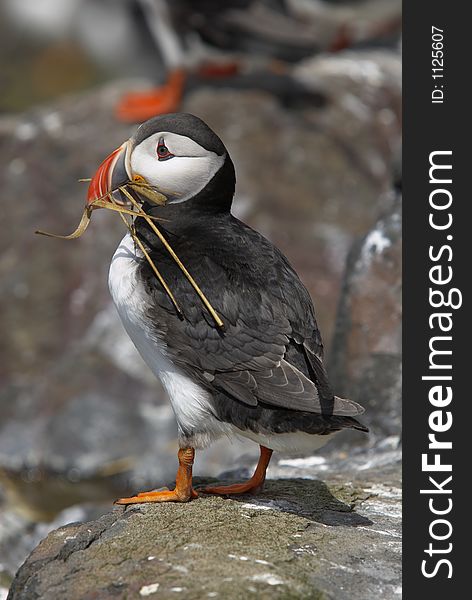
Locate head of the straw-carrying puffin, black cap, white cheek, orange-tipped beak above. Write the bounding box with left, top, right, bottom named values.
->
left=89, top=113, right=235, bottom=212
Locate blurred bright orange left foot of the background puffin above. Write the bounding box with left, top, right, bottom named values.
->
left=115, top=69, right=185, bottom=123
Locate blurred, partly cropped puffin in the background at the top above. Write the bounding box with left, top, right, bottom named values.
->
left=116, top=0, right=401, bottom=122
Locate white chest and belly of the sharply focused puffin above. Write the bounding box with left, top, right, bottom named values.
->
left=108, top=234, right=221, bottom=445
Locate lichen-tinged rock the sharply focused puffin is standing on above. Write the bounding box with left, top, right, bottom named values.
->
left=8, top=447, right=401, bottom=600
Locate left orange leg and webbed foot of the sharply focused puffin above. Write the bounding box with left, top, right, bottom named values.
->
left=115, top=448, right=198, bottom=504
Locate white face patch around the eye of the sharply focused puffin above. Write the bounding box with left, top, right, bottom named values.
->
left=130, top=131, right=225, bottom=204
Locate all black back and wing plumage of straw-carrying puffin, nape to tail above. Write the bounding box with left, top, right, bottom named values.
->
left=138, top=207, right=362, bottom=432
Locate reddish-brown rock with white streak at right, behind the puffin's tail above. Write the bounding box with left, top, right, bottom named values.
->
left=330, top=197, right=402, bottom=437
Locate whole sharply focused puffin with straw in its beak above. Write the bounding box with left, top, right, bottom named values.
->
left=87, top=113, right=368, bottom=505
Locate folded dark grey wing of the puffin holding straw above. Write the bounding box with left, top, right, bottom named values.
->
left=143, top=216, right=361, bottom=416
